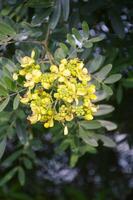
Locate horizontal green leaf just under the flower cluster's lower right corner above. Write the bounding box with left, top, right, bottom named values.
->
left=79, top=120, right=101, bottom=130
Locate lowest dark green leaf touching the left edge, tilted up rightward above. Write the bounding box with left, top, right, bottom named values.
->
left=0, top=167, right=18, bottom=186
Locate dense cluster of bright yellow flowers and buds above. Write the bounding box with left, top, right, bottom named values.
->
left=13, top=51, right=97, bottom=134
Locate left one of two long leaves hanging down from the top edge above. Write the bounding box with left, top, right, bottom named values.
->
left=49, top=0, right=61, bottom=29
